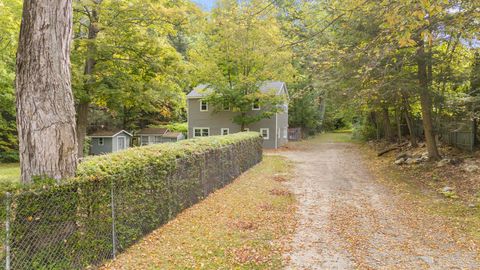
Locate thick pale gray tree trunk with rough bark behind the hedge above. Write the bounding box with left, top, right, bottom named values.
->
left=16, top=0, right=77, bottom=183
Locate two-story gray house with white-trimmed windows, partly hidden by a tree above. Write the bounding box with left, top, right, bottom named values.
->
left=187, top=82, right=288, bottom=148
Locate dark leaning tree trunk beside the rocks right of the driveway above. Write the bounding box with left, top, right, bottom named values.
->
left=416, top=40, right=440, bottom=160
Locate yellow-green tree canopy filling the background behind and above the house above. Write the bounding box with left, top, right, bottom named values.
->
left=0, top=0, right=480, bottom=162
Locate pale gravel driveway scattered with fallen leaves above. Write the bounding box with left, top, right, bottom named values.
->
left=282, top=139, right=480, bottom=269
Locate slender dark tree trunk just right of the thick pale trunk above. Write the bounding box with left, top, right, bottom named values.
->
left=77, top=4, right=102, bottom=157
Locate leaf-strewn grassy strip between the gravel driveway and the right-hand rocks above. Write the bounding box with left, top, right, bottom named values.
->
left=363, top=146, right=480, bottom=243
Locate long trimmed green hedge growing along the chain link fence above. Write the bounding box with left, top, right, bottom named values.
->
left=1, top=132, right=262, bottom=269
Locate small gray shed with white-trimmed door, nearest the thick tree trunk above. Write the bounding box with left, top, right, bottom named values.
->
left=88, top=130, right=132, bottom=155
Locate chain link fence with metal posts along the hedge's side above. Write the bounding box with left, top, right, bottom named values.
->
left=0, top=141, right=262, bottom=270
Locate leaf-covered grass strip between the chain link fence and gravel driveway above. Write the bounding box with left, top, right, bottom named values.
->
left=103, top=156, right=295, bottom=269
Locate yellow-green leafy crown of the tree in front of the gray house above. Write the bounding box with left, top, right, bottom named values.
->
left=191, top=0, right=293, bottom=126
